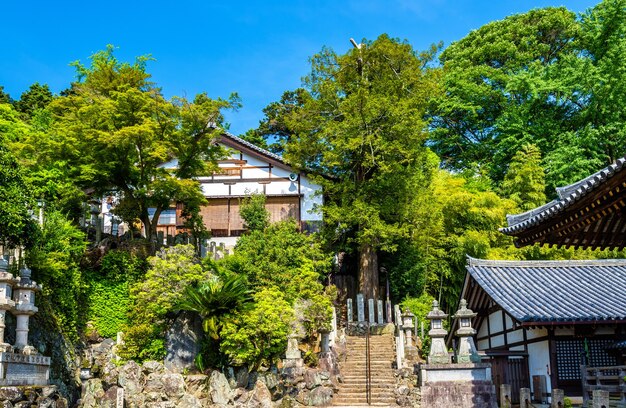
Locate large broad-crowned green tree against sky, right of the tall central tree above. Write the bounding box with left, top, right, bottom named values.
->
left=431, top=7, right=589, bottom=185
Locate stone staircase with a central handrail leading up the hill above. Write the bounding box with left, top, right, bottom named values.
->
left=332, top=334, right=396, bottom=407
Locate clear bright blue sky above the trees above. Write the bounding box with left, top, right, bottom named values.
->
left=0, top=0, right=598, bottom=134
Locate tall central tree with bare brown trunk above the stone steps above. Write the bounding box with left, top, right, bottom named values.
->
left=284, top=35, right=439, bottom=298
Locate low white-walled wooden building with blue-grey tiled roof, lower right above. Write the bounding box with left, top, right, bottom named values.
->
left=461, top=258, right=626, bottom=399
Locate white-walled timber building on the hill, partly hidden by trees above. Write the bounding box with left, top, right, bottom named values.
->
left=152, top=133, right=323, bottom=247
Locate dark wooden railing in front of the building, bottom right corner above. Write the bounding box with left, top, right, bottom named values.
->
left=581, top=366, right=626, bottom=404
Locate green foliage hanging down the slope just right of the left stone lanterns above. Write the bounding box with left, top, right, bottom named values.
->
left=27, top=212, right=86, bottom=340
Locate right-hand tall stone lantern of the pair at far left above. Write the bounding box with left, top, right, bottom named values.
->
left=11, top=266, right=41, bottom=355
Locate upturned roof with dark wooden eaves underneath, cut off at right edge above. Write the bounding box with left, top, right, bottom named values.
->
left=500, top=157, right=626, bottom=248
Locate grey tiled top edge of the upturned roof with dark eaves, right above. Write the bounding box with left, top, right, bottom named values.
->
left=500, top=157, right=626, bottom=235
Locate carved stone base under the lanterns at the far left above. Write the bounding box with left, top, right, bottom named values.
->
left=0, top=353, right=50, bottom=386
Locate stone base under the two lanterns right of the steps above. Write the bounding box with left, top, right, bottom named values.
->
left=421, top=381, right=498, bottom=408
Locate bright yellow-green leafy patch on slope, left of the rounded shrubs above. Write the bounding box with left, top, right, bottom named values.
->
left=86, top=273, right=130, bottom=338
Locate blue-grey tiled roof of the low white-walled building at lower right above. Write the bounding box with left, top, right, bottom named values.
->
left=467, top=257, right=626, bottom=322
